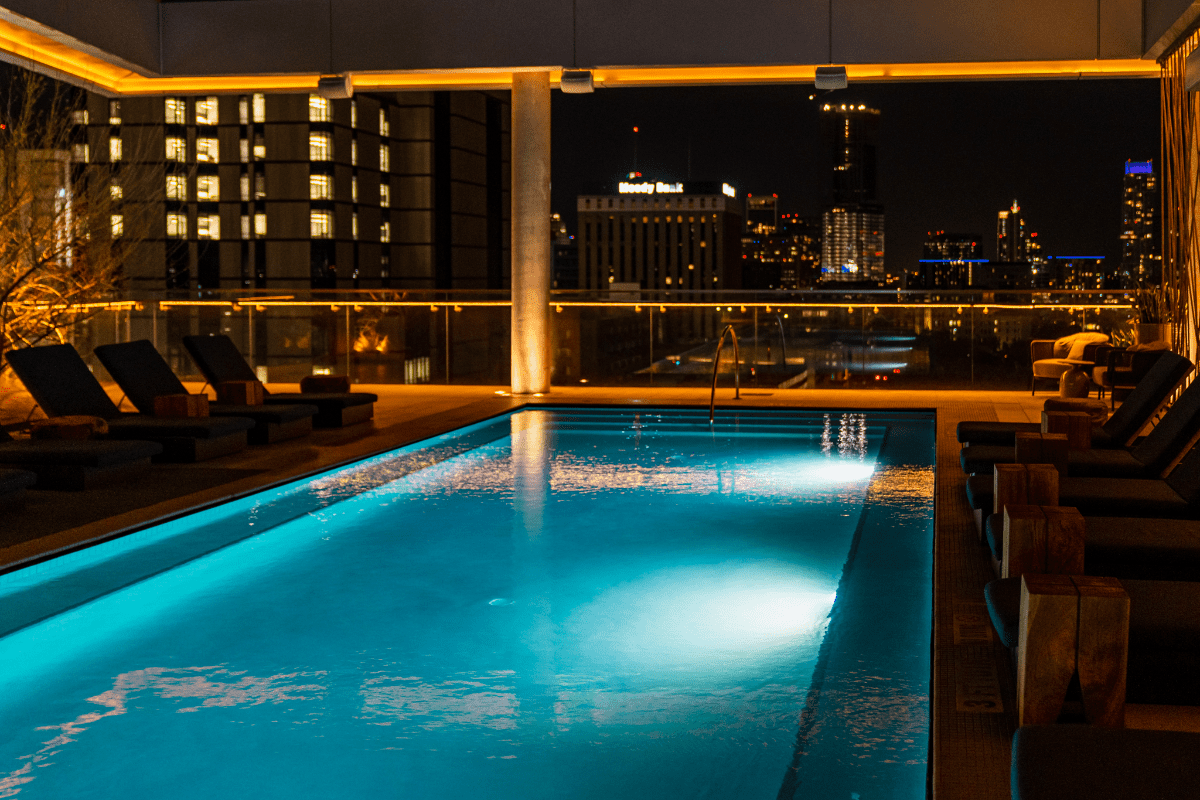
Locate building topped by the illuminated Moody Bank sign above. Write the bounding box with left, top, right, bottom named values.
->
left=576, top=178, right=743, bottom=291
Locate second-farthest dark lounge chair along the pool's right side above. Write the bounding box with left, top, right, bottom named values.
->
left=959, top=371, right=1200, bottom=477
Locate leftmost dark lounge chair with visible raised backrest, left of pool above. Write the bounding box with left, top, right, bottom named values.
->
left=5, top=344, right=254, bottom=463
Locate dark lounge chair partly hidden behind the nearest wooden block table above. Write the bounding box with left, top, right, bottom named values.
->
left=984, top=578, right=1200, bottom=705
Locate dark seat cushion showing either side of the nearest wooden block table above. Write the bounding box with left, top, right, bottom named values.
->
left=983, top=578, right=1200, bottom=652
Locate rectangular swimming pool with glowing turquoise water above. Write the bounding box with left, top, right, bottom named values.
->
left=0, top=408, right=934, bottom=800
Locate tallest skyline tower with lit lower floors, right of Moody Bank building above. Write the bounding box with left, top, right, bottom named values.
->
left=821, top=103, right=887, bottom=283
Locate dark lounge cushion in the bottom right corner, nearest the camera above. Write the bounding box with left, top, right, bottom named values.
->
left=1012, top=724, right=1200, bottom=800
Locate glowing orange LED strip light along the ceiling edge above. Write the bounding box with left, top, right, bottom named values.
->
left=0, top=19, right=1159, bottom=95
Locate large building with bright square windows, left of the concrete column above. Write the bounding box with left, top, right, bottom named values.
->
left=74, top=91, right=510, bottom=290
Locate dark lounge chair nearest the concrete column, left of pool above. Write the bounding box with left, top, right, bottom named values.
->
left=184, top=336, right=379, bottom=428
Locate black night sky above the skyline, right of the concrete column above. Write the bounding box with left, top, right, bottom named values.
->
left=551, top=79, right=1159, bottom=273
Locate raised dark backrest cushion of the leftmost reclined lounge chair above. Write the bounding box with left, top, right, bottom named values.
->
left=5, top=344, right=120, bottom=420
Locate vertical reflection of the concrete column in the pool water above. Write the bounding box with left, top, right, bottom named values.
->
left=510, top=410, right=556, bottom=687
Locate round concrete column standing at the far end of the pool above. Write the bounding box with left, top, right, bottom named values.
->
left=511, top=72, right=553, bottom=395
